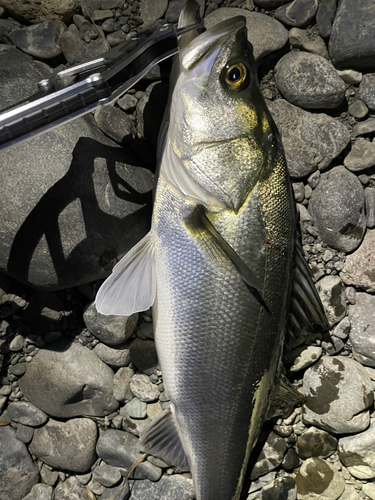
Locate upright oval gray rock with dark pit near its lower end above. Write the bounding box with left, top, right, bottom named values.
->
left=309, top=166, right=366, bottom=252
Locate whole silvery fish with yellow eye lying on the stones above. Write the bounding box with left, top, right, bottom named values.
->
left=96, top=0, right=327, bottom=500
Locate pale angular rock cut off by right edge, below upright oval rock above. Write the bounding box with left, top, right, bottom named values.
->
left=340, top=230, right=375, bottom=293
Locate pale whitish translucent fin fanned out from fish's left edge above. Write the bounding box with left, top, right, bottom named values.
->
left=95, top=231, right=156, bottom=316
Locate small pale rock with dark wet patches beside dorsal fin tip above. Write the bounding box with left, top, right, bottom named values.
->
left=316, top=276, right=347, bottom=326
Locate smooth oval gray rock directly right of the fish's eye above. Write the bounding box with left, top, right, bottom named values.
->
left=275, top=52, right=345, bottom=109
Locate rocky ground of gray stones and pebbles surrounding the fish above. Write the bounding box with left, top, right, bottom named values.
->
left=0, top=0, right=375, bottom=500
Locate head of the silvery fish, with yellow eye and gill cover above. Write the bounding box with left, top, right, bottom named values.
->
left=169, top=16, right=279, bottom=212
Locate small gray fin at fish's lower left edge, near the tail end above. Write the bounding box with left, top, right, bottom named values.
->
left=139, top=404, right=190, bottom=471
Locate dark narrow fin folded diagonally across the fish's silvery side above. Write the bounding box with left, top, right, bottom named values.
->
left=185, top=205, right=270, bottom=313
